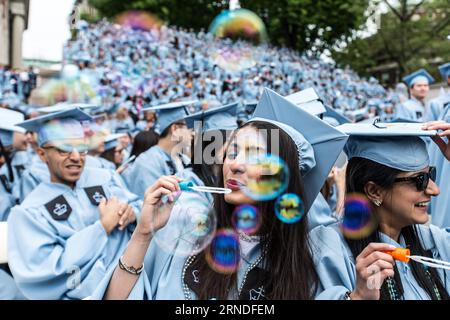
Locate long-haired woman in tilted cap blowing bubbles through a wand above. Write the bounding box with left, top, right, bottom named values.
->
left=94, top=90, right=347, bottom=299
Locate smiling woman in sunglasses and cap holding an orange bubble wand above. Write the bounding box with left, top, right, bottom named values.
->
left=311, top=125, right=450, bottom=300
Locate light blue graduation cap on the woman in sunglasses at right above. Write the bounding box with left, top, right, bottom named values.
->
left=337, top=122, right=437, bottom=172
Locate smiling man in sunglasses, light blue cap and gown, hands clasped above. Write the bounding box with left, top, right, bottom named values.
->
left=8, top=109, right=141, bottom=299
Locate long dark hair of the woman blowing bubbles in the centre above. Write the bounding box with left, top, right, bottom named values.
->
left=193, top=121, right=318, bottom=300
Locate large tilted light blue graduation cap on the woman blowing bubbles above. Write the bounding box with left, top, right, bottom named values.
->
left=250, top=88, right=348, bottom=210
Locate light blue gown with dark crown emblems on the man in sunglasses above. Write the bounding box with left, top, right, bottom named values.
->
left=8, top=167, right=142, bottom=299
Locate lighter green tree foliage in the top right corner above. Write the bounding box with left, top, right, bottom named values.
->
left=333, top=0, right=450, bottom=80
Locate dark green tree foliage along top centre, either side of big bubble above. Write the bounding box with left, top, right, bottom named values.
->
left=90, top=0, right=370, bottom=54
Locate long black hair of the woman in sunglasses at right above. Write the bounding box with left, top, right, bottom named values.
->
left=346, top=157, right=449, bottom=300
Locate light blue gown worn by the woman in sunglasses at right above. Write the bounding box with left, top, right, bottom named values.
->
left=310, top=224, right=450, bottom=300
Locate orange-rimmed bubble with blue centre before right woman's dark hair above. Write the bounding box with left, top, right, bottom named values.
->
left=340, top=193, right=378, bottom=240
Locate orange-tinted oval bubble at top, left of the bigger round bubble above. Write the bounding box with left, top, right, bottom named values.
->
left=115, top=10, right=163, bottom=31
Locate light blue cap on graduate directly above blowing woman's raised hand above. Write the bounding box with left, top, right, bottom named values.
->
left=142, top=100, right=198, bottom=134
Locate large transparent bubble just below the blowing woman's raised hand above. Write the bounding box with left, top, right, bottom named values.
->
left=152, top=193, right=217, bottom=257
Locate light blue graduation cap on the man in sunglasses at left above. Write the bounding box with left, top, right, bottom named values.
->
left=18, top=108, right=92, bottom=146
